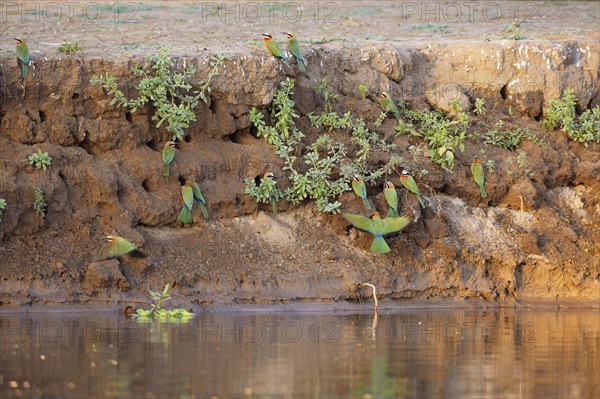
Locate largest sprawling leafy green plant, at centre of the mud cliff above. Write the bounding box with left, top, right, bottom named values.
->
left=247, top=78, right=402, bottom=213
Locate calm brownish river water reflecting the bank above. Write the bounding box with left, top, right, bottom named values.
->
left=0, top=309, right=600, bottom=399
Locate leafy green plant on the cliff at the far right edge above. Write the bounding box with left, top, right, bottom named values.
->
left=541, top=89, right=600, bottom=146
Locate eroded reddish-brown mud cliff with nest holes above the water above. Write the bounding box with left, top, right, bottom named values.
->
left=0, top=39, right=600, bottom=305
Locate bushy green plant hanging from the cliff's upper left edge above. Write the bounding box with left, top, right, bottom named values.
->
left=90, top=47, right=227, bottom=140
